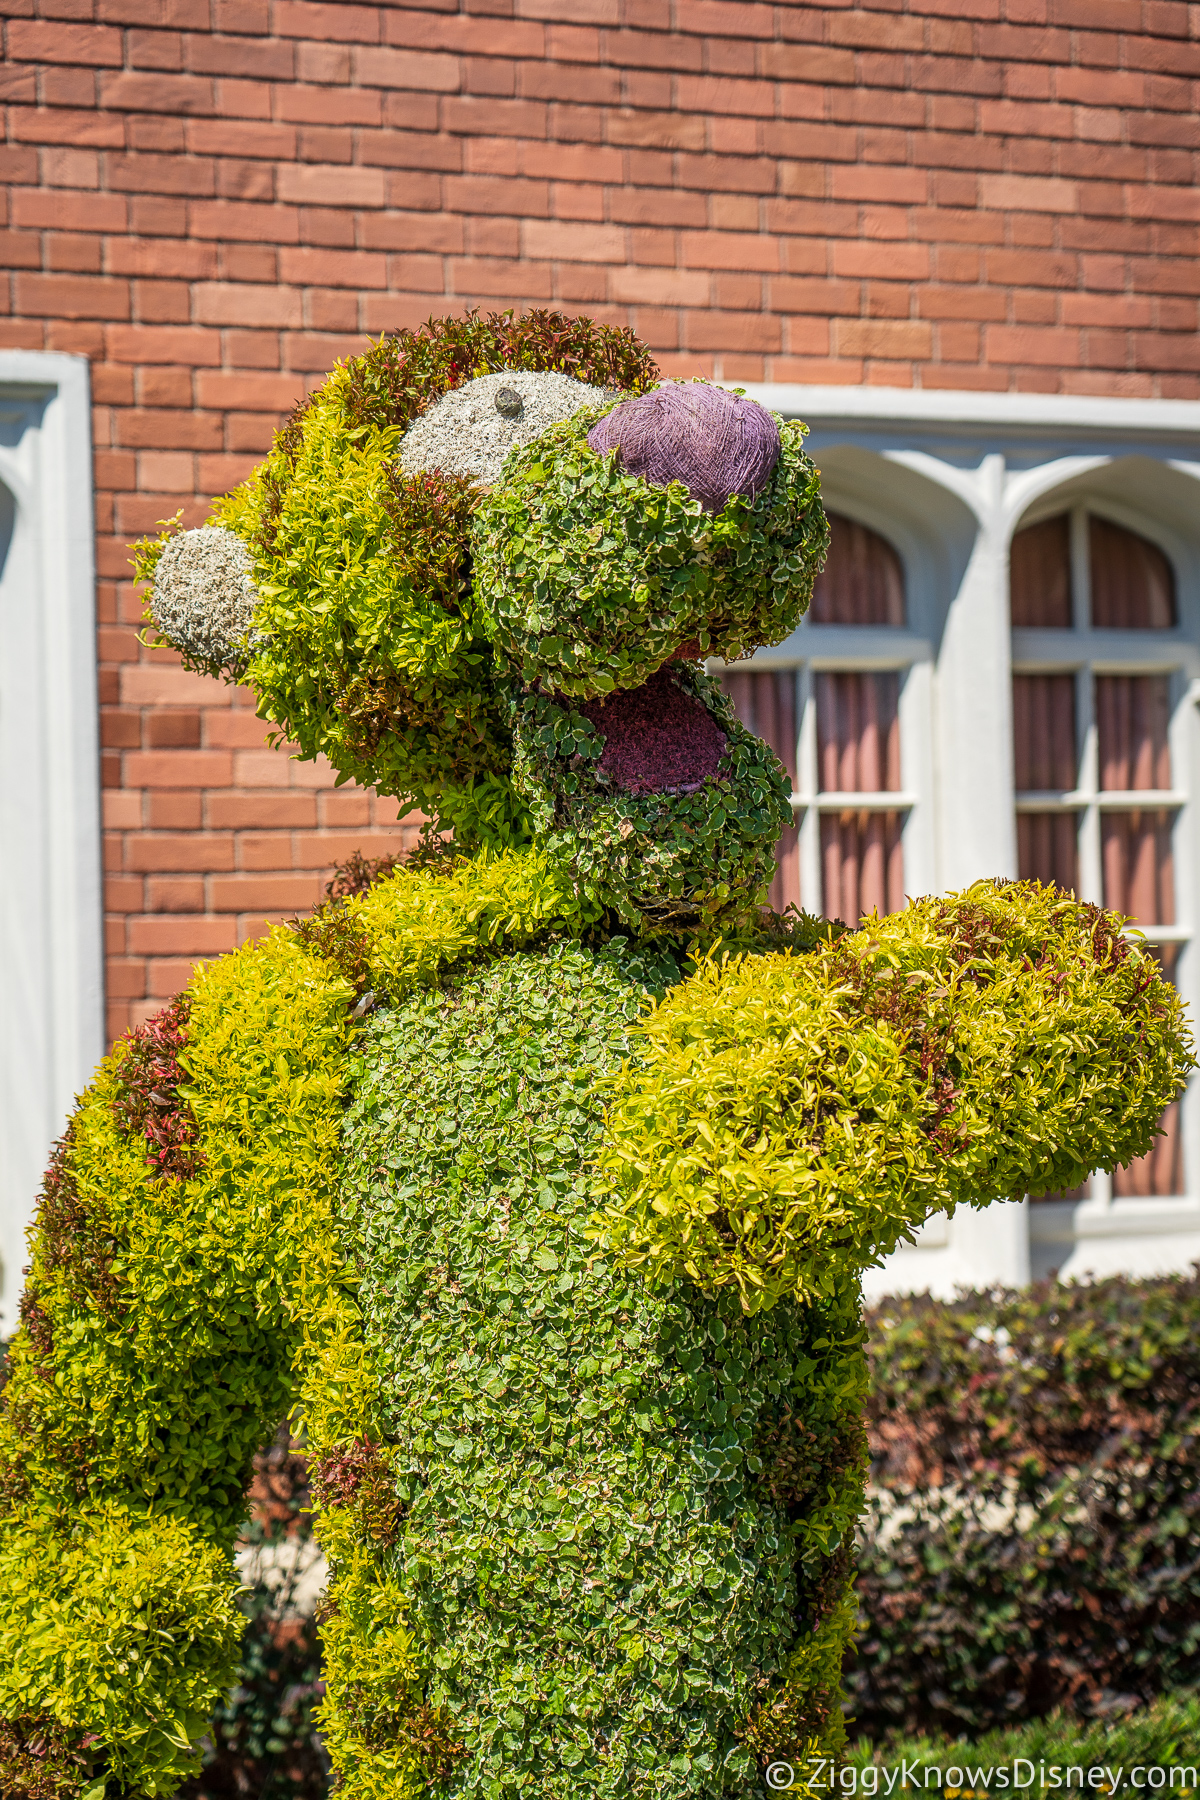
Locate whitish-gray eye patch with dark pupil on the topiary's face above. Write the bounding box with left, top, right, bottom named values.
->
left=399, top=369, right=617, bottom=486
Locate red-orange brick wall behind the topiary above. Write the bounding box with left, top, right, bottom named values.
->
left=0, top=0, right=1200, bottom=1030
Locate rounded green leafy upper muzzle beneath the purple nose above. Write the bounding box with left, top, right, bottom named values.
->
left=473, top=407, right=829, bottom=698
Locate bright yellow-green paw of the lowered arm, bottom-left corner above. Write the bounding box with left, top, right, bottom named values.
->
left=0, top=1507, right=245, bottom=1800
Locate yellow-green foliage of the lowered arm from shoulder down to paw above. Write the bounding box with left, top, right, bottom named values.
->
left=0, top=932, right=349, bottom=1534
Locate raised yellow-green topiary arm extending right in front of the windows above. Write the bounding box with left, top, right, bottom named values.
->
left=599, top=882, right=1195, bottom=1312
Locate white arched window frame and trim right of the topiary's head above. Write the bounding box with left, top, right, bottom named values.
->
left=734, top=385, right=1200, bottom=1294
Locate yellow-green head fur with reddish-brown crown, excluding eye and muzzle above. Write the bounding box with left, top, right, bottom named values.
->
left=189, top=311, right=657, bottom=844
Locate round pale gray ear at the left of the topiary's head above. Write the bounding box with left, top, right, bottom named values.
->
left=149, top=526, right=257, bottom=675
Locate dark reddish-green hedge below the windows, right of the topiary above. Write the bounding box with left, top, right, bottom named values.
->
left=849, top=1271, right=1200, bottom=1748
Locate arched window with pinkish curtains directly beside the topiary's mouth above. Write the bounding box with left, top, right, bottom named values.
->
left=723, top=511, right=925, bottom=925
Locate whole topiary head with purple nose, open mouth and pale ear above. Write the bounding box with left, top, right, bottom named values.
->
left=139, top=313, right=828, bottom=929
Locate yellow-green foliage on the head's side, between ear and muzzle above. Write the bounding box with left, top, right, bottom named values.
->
left=214, top=367, right=520, bottom=839
